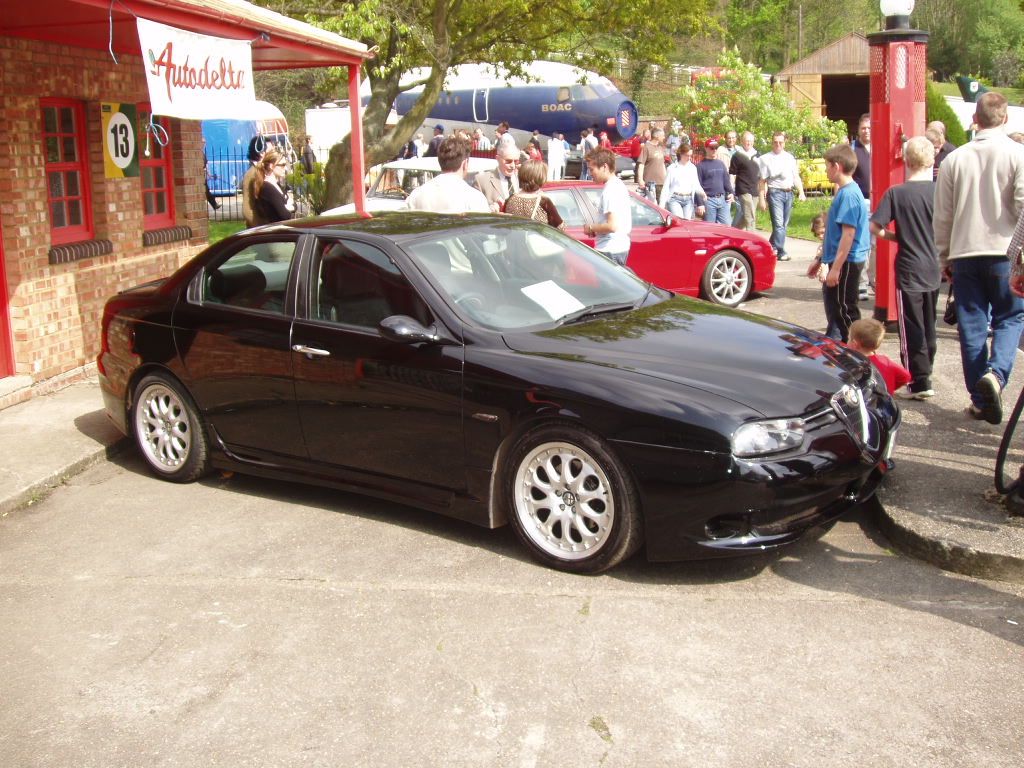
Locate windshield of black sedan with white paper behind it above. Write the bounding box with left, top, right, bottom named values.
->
left=404, top=221, right=650, bottom=331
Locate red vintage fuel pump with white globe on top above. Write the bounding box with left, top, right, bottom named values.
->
left=867, top=0, right=928, bottom=323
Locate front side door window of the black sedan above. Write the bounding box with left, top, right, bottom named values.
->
left=310, top=239, right=433, bottom=330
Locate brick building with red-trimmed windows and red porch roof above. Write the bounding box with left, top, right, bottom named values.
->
left=0, top=0, right=370, bottom=407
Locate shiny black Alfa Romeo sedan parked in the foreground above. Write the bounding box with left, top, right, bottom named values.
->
left=98, top=212, right=899, bottom=573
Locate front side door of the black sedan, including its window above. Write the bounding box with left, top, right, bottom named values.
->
left=292, top=239, right=466, bottom=489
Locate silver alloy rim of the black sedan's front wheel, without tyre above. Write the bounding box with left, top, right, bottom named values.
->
left=513, top=442, right=615, bottom=560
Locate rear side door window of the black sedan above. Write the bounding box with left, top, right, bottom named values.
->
left=202, top=240, right=296, bottom=314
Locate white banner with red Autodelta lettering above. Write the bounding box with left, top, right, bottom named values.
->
left=138, top=18, right=258, bottom=120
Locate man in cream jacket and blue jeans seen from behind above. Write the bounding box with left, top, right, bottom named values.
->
left=933, top=91, right=1024, bottom=424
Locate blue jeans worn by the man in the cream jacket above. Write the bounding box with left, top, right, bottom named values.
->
left=949, top=256, right=1024, bottom=408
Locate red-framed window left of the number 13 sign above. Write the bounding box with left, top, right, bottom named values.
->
left=39, top=98, right=94, bottom=245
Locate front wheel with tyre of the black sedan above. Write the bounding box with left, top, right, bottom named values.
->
left=507, top=426, right=642, bottom=573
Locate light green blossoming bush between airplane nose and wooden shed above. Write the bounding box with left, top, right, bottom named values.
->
left=675, top=49, right=846, bottom=158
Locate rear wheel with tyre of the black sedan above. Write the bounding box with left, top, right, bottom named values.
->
left=132, top=374, right=210, bottom=482
